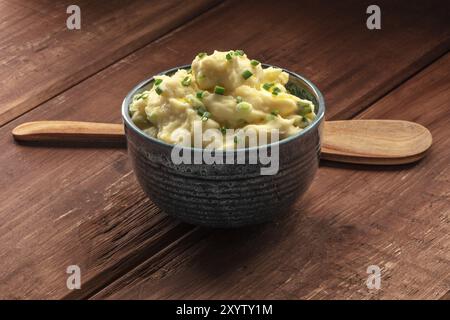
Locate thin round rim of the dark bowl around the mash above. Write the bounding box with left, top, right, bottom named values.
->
left=122, top=63, right=325, bottom=153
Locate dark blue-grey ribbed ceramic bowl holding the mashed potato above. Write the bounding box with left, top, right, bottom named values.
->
left=122, top=65, right=325, bottom=228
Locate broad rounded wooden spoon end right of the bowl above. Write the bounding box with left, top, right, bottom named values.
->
left=321, top=119, right=432, bottom=165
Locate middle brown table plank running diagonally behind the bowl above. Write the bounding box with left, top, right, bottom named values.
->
left=0, top=1, right=449, bottom=298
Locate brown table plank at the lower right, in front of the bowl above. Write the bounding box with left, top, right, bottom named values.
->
left=95, top=54, right=450, bottom=299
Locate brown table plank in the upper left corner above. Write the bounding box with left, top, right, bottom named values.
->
left=0, top=0, right=218, bottom=125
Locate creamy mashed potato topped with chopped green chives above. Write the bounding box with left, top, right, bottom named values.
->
left=130, top=50, right=315, bottom=146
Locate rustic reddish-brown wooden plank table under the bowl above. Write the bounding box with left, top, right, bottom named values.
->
left=0, top=0, right=450, bottom=299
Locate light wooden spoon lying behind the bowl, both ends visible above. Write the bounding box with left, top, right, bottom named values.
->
left=12, top=120, right=432, bottom=165
